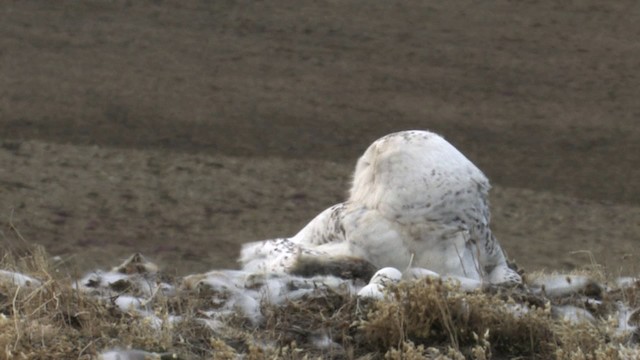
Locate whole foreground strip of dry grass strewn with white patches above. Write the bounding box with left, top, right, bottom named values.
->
left=0, top=249, right=640, bottom=359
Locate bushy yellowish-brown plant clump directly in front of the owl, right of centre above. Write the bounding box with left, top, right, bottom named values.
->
left=360, top=280, right=632, bottom=359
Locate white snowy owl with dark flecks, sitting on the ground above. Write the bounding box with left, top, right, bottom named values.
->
left=240, top=130, right=521, bottom=284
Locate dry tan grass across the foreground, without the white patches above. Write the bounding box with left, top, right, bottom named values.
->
left=0, top=248, right=638, bottom=359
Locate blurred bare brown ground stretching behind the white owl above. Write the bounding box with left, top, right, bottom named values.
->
left=0, top=0, right=640, bottom=274
